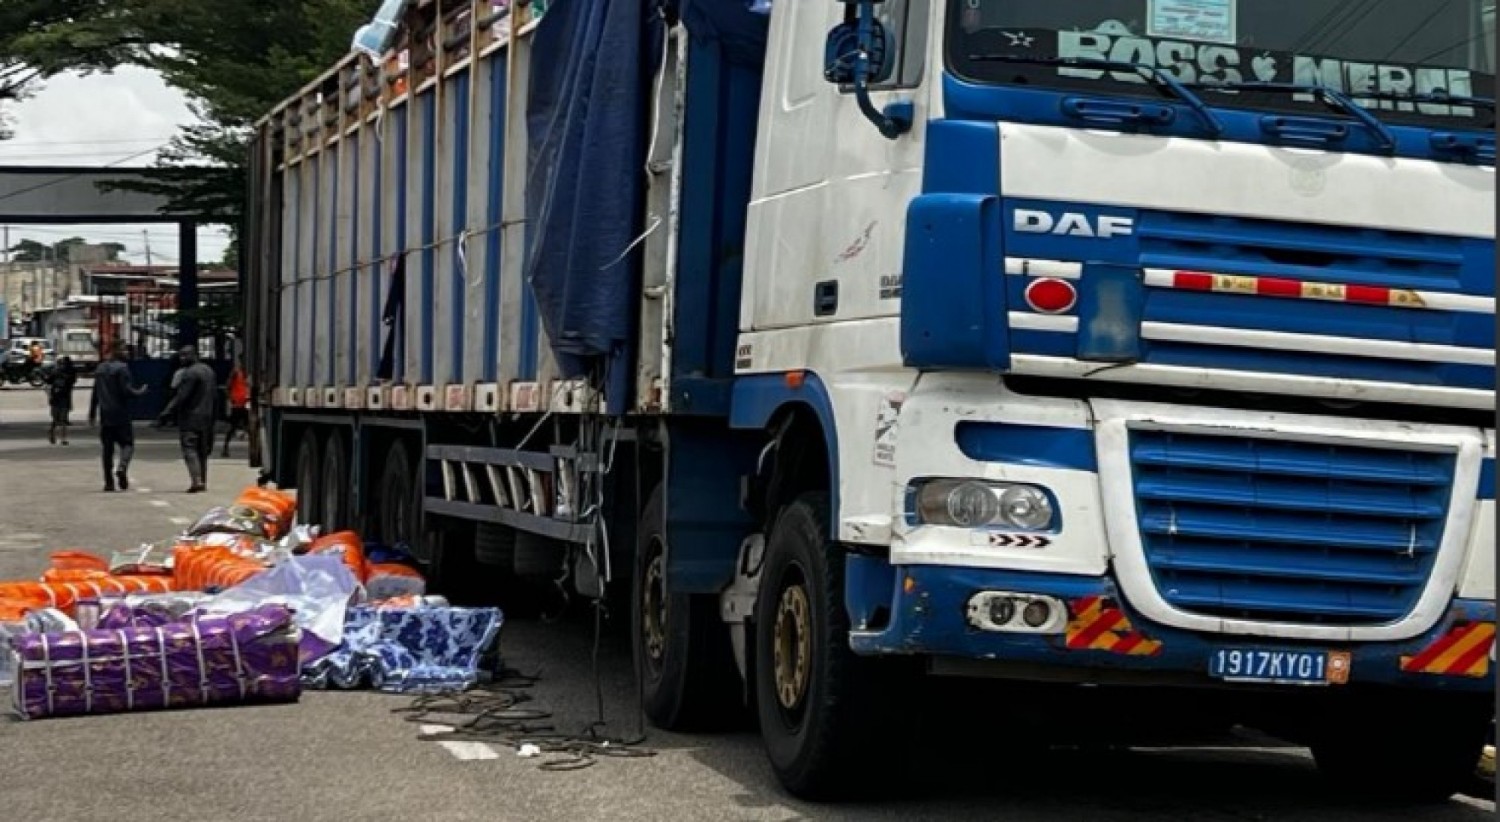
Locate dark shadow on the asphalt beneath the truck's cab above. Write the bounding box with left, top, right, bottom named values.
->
left=501, top=609, right=1494, bottom=821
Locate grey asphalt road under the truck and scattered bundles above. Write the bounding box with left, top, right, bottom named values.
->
left=0, top=389, right=1496, bottom=822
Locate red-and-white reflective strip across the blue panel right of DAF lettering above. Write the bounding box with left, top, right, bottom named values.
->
left=1146, top=269, right=1496, bottom=314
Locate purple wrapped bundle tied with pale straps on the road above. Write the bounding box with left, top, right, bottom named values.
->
left=12, top=605, right=300, bottom=719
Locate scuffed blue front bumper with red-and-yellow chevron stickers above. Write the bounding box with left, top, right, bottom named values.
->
left=846, top=555, right=1496, bottom=692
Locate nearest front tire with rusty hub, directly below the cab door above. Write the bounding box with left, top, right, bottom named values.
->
left=755, top=492, right=923, bottom=800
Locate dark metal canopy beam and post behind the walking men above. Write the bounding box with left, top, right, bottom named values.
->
left=0, top=165, right=222, bottom=345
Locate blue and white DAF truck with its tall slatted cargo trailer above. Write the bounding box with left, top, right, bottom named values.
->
left=245, top=0, right=1496, bottom=798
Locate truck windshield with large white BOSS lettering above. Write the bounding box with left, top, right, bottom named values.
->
left=947, top=0, right=1496, bottom=129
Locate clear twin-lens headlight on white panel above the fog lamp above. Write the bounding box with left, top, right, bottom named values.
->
left=914, top=480, right=1058, bottom=531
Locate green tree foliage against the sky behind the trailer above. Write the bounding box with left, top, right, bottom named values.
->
left=0, top=0, right=380, bottom=222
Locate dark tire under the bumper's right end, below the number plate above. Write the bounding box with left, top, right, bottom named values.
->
left=1311, top=693, right=1494, bottom=803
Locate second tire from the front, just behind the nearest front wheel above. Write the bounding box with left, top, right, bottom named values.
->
left=630, top=486, right=746, bottom=732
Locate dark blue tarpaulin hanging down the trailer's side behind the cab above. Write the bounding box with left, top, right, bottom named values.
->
left=527, top=0, right=665, bottom=378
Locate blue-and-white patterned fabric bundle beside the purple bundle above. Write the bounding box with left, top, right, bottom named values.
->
left=303, top=603, right=503, bottom=693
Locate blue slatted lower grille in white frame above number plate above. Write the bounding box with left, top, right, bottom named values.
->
left=1130, top=431, right=1457, bottom=626
